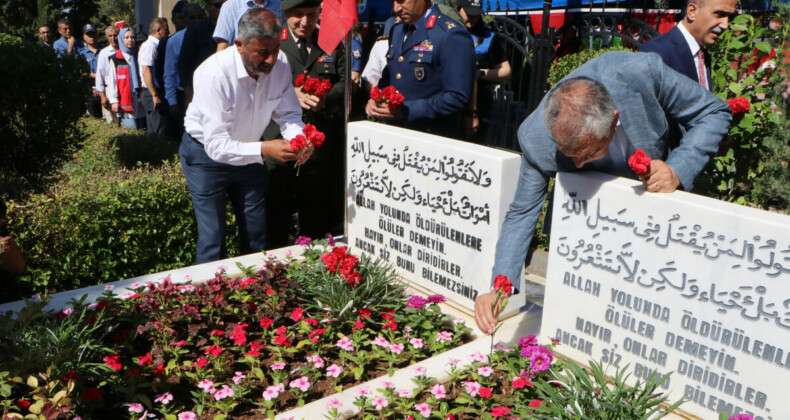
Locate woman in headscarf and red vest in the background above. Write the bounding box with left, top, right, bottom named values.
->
left=107, top=28, right=145, bottom=129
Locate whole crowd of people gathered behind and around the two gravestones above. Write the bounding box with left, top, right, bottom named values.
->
left=39, top=0, right=735, bottom=332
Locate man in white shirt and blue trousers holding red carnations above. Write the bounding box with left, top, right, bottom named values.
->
left=179, top=8, right=313, bottom=263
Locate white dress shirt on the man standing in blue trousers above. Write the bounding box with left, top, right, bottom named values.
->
left=184, top=46, right=304, bottom=165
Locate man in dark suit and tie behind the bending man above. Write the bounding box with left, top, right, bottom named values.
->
left=639, top=0, right=738, bottom=90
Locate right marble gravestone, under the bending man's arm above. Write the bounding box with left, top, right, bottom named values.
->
left=541, top=173, right=790, bottom=420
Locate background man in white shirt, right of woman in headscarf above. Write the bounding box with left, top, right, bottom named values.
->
left=137, top=18, right=170, bottom=134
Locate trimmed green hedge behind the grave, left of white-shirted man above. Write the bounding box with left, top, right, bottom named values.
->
left=2, top=120, right=238, bottom=300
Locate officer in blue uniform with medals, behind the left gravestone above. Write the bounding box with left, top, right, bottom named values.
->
left=366, top=0, right=475, bottom=138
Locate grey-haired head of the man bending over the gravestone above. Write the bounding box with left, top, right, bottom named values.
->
left=543, top=77, right=614, bottom=153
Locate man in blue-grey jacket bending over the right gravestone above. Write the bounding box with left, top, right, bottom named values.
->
left=475, top=52, right=732, bottom=334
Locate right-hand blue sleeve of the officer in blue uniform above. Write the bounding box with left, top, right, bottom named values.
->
left=403, top=29, right=475, bottom=124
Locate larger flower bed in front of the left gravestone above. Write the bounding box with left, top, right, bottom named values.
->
left=0, top=243, right=470, bottom=420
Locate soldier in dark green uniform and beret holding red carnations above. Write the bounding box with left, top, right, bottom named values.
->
left=266, top=0, right=346, bottom=247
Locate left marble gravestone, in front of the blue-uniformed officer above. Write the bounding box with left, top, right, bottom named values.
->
left=346, top=121, right=523, bottom=315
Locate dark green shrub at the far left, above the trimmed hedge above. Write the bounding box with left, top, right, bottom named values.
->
left=0, top=35, right=90, bottom=194
